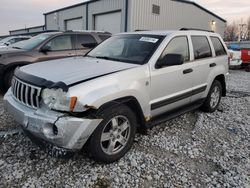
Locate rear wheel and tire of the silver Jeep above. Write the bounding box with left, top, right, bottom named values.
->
left=201, top=80, right=222, bottom=112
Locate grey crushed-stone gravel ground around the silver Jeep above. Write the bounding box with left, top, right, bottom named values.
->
left=0, top=71, right=250, bottom=187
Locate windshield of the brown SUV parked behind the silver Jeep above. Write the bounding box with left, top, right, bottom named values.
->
left=11, top=33, right=54, bottom=50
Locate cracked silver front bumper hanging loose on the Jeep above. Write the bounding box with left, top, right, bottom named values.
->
left=4, top=90, right=102, bottom=155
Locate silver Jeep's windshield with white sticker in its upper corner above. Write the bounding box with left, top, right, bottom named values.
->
left=87, top=34, right=163, bottom=65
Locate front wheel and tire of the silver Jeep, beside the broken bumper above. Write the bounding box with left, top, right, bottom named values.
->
left=88, top=105, right=137, bottom=163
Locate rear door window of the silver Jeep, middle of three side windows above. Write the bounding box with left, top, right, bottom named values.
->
left=191, top=36, right=212, bottom=59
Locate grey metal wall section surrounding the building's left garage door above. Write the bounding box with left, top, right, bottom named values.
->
left=45, top=5, right=86, bottom=30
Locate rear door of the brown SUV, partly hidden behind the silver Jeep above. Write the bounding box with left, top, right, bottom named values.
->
left=74, top=34, right=98, bottom=56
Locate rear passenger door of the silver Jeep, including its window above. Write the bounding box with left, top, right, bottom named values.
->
left=191, top=35, right=216, bottom=102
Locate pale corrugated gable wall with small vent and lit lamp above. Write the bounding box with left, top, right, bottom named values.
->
left=130, top=0, right=226, bottom=36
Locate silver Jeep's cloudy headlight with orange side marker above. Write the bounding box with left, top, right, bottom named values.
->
left=42, top=89, right=77, bottom=112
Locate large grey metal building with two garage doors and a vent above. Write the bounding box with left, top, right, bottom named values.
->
left=44, top=0, right=226, bottom=36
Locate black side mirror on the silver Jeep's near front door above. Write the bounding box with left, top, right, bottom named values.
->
left=156, top=54, right=184, bottom=68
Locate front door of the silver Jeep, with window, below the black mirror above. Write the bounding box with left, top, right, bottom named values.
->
left=150, top=36, right=193, bottom=116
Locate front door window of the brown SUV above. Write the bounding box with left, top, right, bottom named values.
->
left=46, top=35, right=72, bottom=51
